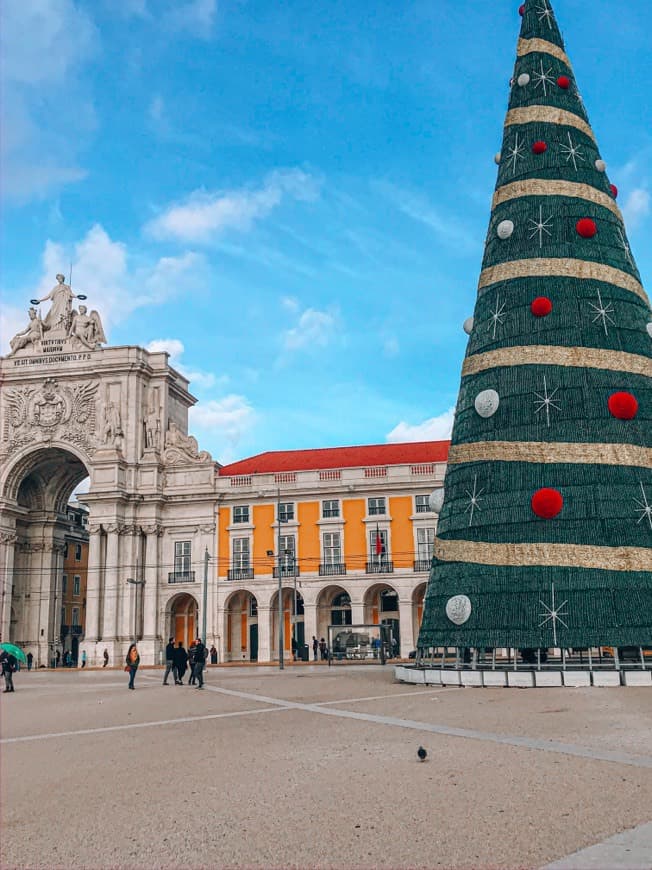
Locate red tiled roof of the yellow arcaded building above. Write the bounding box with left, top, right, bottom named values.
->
left=219, top=441, right=450, bottom=477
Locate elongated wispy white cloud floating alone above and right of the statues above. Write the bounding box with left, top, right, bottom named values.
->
left=145, top=169, right=318, bottom=243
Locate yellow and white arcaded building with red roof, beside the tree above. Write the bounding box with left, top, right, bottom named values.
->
left=214, top=441, right=449, bottom=661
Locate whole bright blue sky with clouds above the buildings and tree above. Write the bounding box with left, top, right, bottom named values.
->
left=0, top=0, right=652, bottom=462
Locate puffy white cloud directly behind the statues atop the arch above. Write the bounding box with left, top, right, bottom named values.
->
left=21, top=224, right=206, bottom=333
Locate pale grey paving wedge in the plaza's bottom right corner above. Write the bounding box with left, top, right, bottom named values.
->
left=542, top=822, right=652, bottom=870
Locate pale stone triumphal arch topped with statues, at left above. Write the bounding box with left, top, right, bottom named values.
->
left=0, top=275, right=216, bottom=664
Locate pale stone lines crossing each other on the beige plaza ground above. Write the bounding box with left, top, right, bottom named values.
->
left=5, top=676, right=652, bottom=769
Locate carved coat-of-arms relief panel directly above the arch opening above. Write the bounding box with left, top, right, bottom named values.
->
left=3, top=378, right=98, bottom=455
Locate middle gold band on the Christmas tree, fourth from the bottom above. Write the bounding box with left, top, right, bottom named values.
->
left=478, top=257, right=650, bottom=305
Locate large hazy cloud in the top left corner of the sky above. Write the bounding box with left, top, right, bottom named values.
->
left=0, top=0, right=99, bottom=201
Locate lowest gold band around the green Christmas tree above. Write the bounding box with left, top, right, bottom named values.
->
left=435, top=538, right=652, bottom=571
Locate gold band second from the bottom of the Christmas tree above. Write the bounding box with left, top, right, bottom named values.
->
left=448, top=441, right=652, bottom=468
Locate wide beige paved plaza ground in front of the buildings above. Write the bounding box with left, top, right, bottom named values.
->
left=0, top=665, right=652, bottom=868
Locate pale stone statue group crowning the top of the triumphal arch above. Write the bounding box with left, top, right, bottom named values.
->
left=9, top=275, right=106, bottom=356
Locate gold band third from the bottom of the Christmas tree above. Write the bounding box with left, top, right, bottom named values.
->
left=462, top=344, right=652, bottom=377
